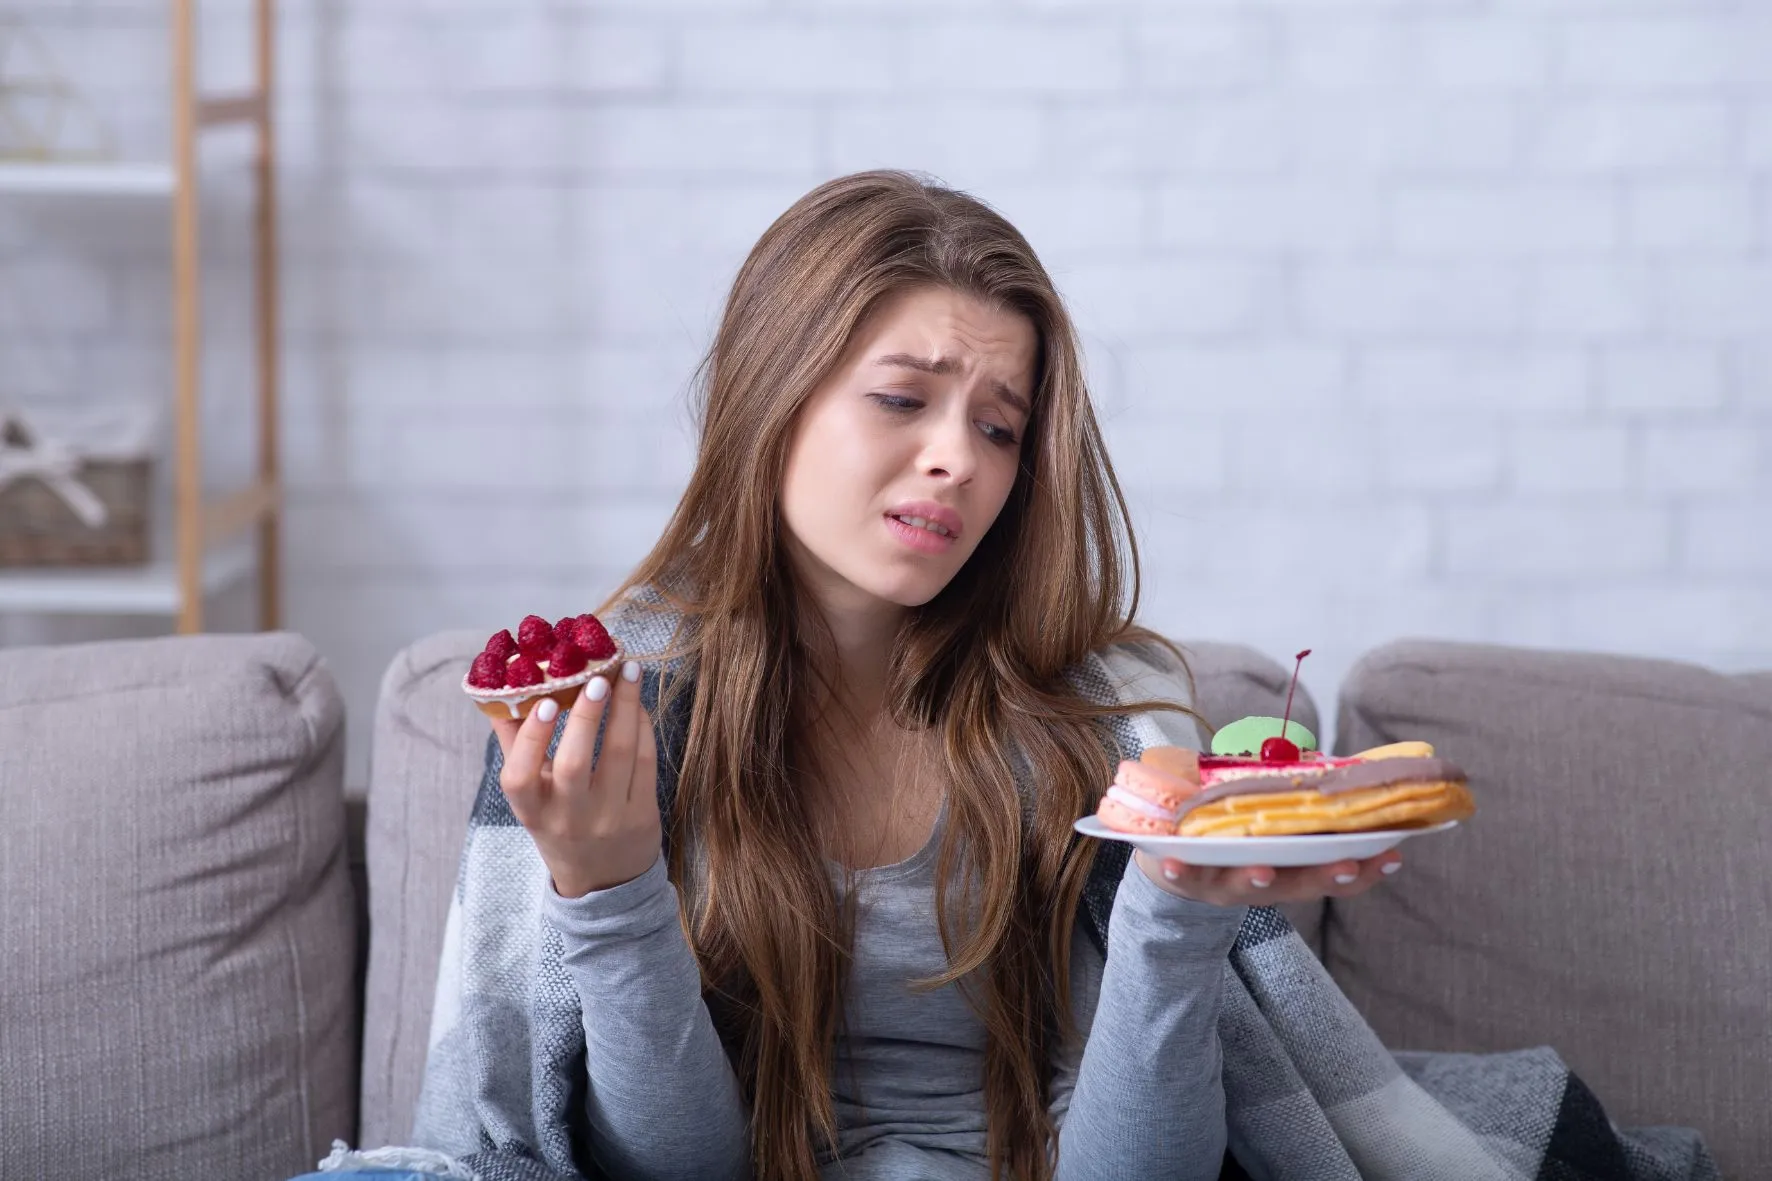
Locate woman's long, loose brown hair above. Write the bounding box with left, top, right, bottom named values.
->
left=604, top=172, right=1191, bottom=1181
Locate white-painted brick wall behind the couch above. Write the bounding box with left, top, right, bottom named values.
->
left=0, top=0, right=1772, bottom=777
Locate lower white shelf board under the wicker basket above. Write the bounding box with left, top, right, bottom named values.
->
left=0, top=537, right=259, bottom=615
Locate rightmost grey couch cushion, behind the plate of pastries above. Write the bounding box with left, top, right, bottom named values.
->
left=1325, top=642, right=1772, bottom=1176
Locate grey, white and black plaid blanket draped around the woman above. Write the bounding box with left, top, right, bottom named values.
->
left=363, top=599, right=1719, bottom=1181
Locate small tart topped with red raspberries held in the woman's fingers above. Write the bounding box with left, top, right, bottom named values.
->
left=461, top=614, right=622, bottom=718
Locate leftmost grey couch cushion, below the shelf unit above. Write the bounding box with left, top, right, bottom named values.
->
left=0, top=633, right=358, bottom=1181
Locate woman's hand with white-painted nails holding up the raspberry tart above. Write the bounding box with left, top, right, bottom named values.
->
left=493, top=661, right=661, bottom=897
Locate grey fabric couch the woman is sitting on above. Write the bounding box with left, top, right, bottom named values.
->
left=0, top=633, right=1772, bottom=1181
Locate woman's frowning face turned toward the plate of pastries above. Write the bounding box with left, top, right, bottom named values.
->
left=780, top=287, right=1038, bottom=610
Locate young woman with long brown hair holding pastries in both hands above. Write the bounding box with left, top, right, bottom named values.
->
left=318, top=172, right=1400, bottom=1179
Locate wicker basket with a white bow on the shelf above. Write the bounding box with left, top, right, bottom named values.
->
left=0, top=417, right=152, bottom=567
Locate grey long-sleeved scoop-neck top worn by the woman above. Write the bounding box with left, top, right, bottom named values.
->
left=546, top=808, right=1244, bottom=1181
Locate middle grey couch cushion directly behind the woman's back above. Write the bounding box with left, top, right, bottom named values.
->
left=361, top=631, right=1320, bottom=1146
